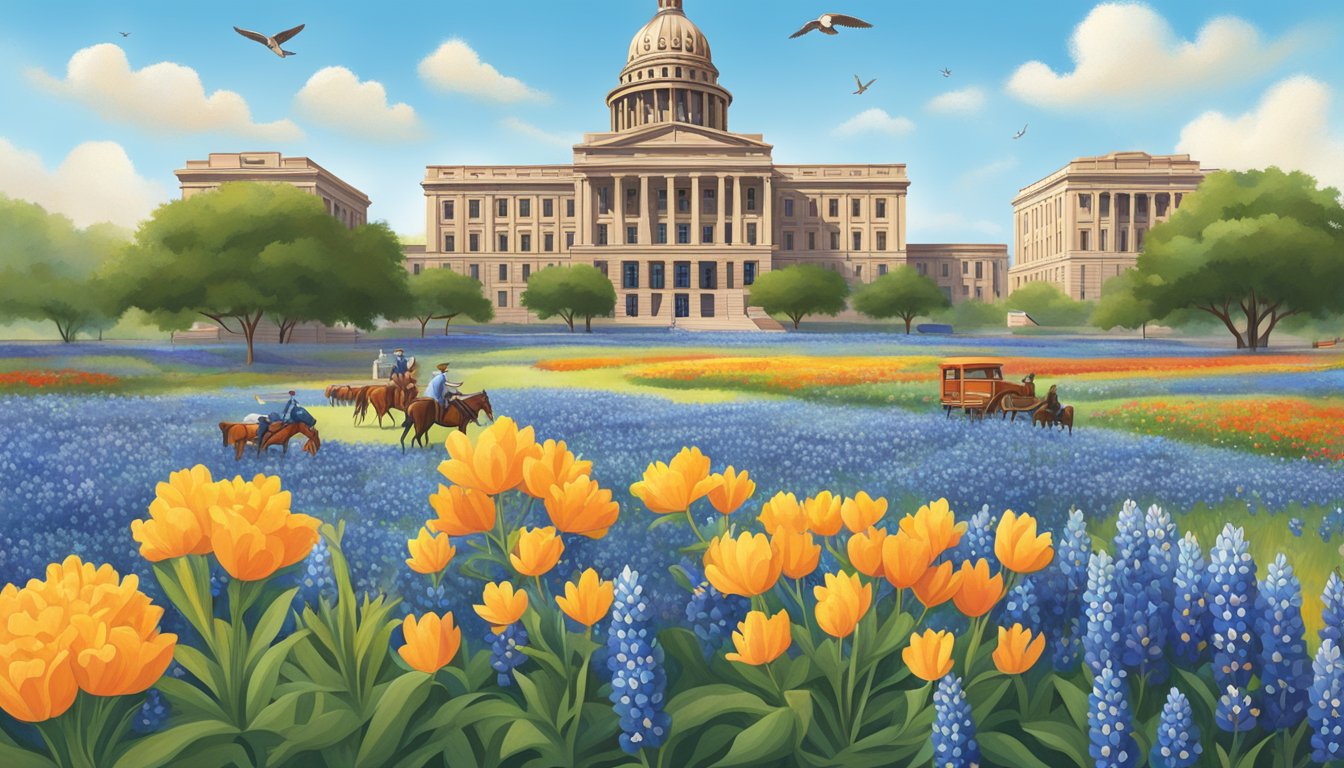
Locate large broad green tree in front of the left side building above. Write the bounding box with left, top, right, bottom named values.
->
left=113, top=182, right=410, bottom=364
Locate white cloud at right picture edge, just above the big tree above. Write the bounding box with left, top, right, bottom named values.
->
left=1176, top=75, right=1344, bottom=190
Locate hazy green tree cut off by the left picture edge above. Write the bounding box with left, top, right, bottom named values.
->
left=0, top=195, right=126, bottom=343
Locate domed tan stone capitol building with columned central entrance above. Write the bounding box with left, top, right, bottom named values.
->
left=407, top=0, right=1008, bottom=330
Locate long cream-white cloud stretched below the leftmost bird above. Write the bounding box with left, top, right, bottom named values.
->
left=28, top=43, right=302, bottom=141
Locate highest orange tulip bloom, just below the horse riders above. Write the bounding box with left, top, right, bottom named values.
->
left=438, top=416, right=542, bottom=496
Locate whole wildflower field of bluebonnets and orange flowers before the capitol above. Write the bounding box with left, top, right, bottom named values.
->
left=0, top=335, right=1344, bottom=768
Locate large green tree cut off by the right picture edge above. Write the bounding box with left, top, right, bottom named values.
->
left=1136, top=168, right=1344, bottom=351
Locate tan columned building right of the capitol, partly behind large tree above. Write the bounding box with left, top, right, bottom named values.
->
left=1008, top=152, right=1208, bottom=300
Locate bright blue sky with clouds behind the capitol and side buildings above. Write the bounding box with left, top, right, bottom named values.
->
left=0, top=0, right=1344, bottom=252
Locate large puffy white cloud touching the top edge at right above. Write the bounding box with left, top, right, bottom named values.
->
left=1007, top=3, right=1293, bottom=108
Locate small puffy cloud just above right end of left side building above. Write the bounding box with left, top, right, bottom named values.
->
left=294, top=67, right=422, bottom=141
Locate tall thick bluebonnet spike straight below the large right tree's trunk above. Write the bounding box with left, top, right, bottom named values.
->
left=1208, top=523, right=1259, bottom=690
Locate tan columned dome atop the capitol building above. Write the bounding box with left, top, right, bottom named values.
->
left=606, top=0, right=732, bottom=132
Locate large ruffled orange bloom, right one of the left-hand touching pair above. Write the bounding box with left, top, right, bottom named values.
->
left=210, top=475, right=321, bottom=581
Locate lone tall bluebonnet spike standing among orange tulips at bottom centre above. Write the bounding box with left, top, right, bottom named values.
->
left=606, top=566, right=671, bottom=755
